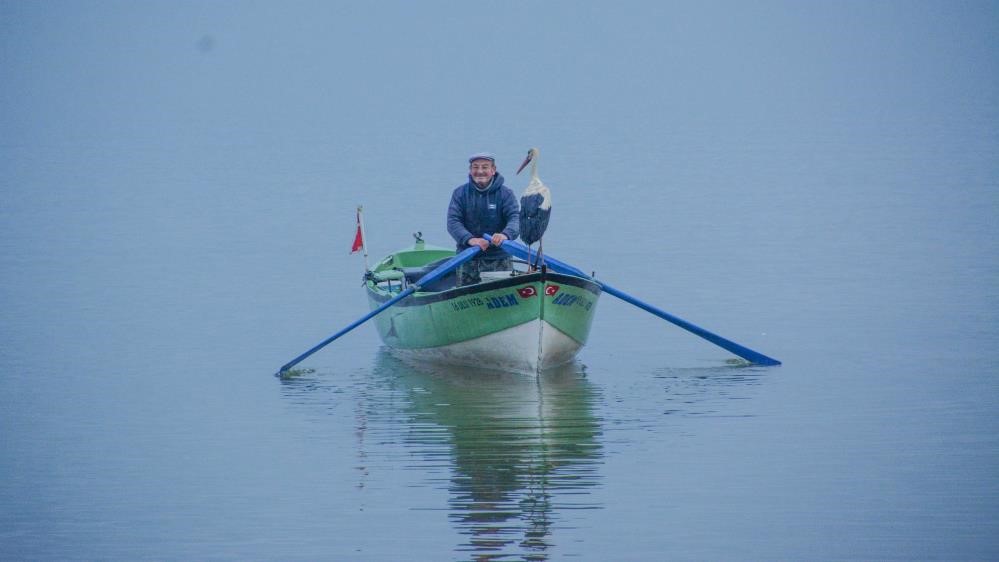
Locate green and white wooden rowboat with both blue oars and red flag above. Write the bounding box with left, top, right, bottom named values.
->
left=275, top=230, right=781, bottom=377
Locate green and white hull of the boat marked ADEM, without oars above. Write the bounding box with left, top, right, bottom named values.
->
left=366, top=241, right=600, bottom=374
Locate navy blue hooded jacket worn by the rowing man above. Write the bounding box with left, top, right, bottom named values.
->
left=447, top=172, right=520, bottom=259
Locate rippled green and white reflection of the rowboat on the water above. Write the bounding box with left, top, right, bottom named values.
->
left=390, top=354, right=602, bottom=559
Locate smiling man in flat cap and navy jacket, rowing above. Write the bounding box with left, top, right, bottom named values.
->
left=447, top=152, right=520, bottom=286
